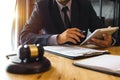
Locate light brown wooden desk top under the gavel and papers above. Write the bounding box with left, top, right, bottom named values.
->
left=0, top=47, right=120, bottom=80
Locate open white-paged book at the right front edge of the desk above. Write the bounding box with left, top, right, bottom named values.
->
left=73, top=54, right=120, bottom=76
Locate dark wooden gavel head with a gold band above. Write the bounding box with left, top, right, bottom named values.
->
left=18, top=44, right=44, bottom=62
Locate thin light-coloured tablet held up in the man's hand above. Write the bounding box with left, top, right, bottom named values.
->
left=80, top=27, right=119, bottom=45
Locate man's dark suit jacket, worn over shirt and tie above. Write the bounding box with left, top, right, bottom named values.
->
left=20, top=0, right=105, bottom=45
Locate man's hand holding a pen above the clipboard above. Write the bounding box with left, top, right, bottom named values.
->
left=57, top=28, right=85, bottom=44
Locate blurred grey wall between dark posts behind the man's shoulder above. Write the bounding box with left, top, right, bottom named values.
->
left=91, top=0, right=114, bottom=26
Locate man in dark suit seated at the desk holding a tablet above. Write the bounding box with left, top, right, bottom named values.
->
left=20, top=0, right=112, bottom=47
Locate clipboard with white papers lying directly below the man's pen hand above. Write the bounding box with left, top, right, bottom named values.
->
left=44, top=45, right=109, bottom=59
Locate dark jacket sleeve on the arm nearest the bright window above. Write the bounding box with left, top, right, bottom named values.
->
left=19, top=3, right=51, bottom=45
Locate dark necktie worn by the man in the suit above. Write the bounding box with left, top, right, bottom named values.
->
left=62, top=6, right=70, bottom=28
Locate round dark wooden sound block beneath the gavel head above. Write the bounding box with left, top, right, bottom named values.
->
left=6, top=57, right=51, bottom=74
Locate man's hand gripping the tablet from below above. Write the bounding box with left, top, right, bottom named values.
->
left=87, top=34, right=112, bottom=48
